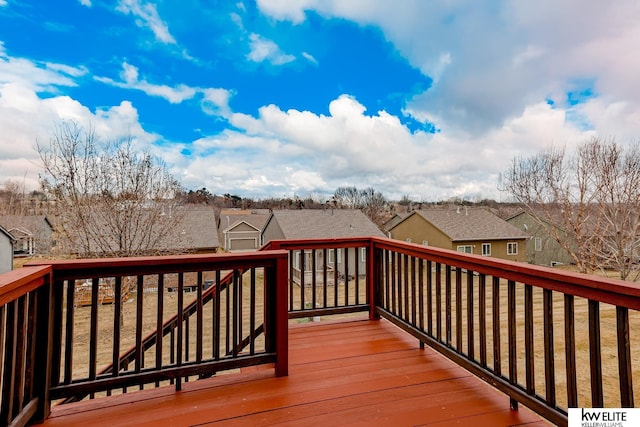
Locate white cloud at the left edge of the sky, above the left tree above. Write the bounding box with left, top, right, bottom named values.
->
left=0, top=50, right=158, bottom=190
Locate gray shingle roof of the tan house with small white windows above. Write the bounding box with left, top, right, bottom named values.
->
left=412, top=207, right=529, bottom=241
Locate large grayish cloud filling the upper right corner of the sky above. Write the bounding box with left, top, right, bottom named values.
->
left=257, top=0, right=640, bottom=139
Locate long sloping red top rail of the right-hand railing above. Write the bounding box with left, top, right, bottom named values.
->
left=372, top=237, right=640, bottom=310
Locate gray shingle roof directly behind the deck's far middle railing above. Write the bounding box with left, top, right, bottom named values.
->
left=265, top=209, right=384, bottom=239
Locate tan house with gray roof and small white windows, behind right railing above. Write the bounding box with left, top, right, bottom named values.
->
left=389, top=206, right=529, bottom=261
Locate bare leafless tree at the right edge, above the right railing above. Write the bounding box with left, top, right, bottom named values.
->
left=502, top=138, right=640, bottom=280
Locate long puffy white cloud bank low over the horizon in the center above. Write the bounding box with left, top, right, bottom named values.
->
left=170, top=95, right=590, bottom=199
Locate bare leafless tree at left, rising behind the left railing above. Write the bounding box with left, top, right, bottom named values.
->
left=37, top=122, right=180, bottom=256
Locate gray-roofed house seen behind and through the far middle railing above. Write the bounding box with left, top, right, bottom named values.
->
left=262, top=208, right=385, bottom=283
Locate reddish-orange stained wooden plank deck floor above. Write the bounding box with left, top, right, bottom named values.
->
left=43, top=319, right=549, bottom=427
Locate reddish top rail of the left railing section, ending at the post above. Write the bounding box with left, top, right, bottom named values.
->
left=27, top=250, right=288, bottom=279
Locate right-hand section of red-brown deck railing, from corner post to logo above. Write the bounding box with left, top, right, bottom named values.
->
left=373, top=239, right=640, bottom=425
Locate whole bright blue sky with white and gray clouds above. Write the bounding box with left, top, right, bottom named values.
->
left=0, top=0, right=640, bottom=201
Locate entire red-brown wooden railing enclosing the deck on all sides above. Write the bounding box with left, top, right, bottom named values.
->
left=0, top=237, right=640, bottom=425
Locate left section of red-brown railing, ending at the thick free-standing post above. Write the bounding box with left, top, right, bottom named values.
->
left=0, top=251, right=288, bottom=425
